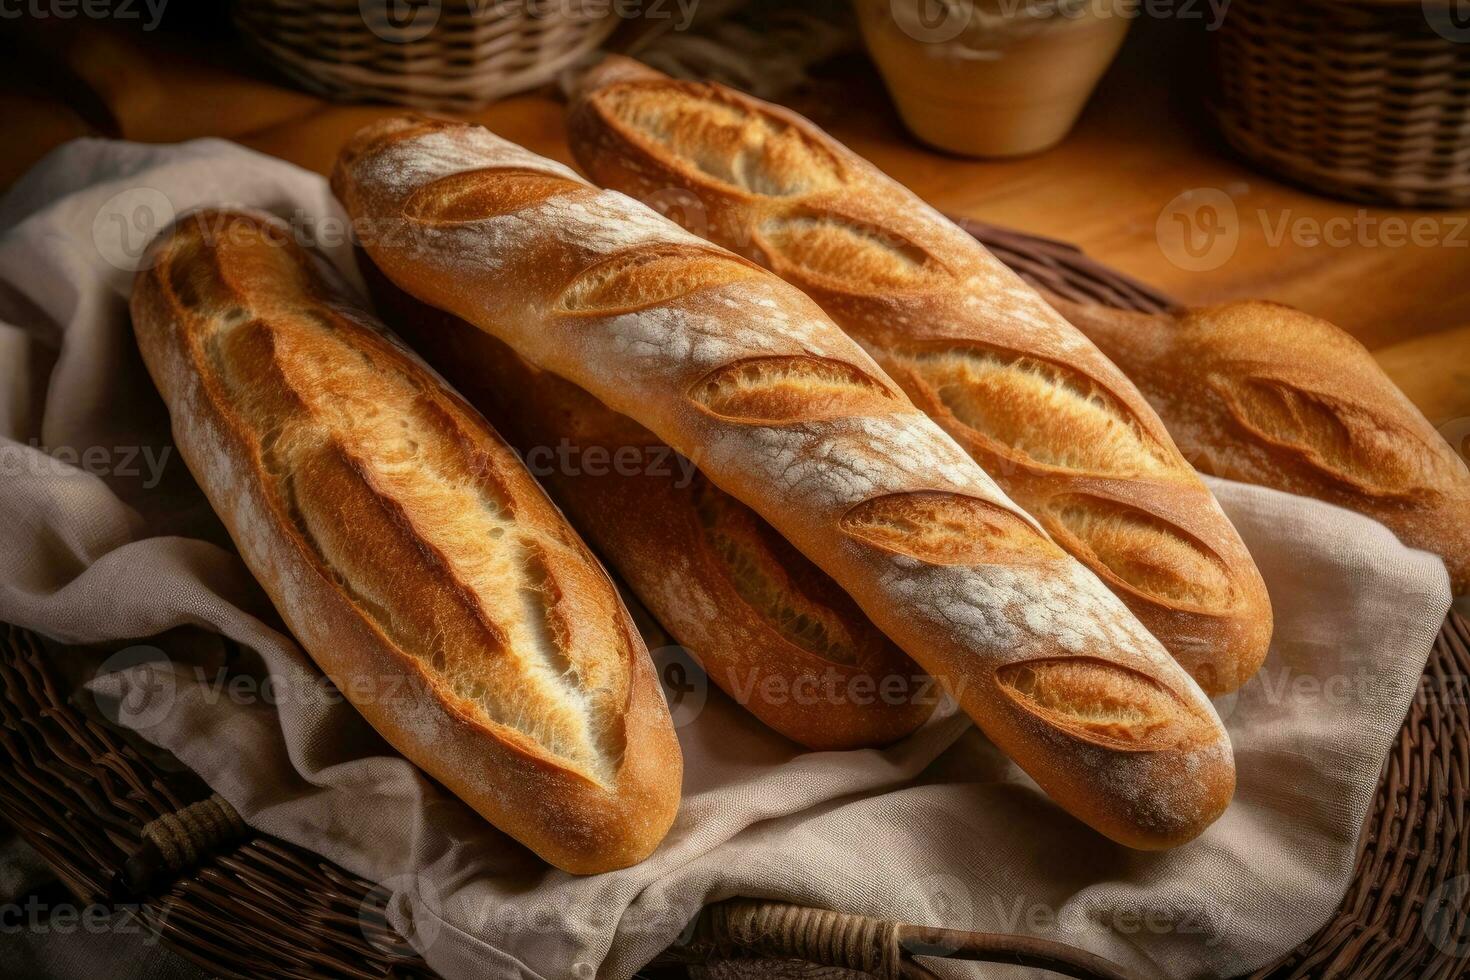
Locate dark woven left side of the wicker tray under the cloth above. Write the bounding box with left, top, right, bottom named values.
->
left=0, top=626, right=434, bottom=979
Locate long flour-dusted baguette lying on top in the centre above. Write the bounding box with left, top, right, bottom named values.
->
left=332, top=116, right=1235, bottom=848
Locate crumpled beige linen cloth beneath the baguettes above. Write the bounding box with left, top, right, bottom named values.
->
left=0, top=140, right=1449, bottom=980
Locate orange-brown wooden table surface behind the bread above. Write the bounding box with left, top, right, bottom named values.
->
left=0, top=22, right=1470, bottom=430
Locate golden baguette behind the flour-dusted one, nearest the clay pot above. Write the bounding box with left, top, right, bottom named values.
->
left=567, top=57, right=1272, bottom=695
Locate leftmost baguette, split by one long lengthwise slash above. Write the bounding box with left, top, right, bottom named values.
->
left=132, top=212, right=682, bottom=873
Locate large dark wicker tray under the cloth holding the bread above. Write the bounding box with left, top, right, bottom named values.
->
left=0, top=222, right=1470, bottom=980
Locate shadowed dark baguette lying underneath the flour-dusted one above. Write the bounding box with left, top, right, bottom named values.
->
left=359, top=257, right=938, bottom=751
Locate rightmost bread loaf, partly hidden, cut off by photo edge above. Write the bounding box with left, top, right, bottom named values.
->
left=1053, top=298, right=1470, bottom=595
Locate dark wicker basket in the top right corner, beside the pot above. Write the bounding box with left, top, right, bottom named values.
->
left=1213, top=0, right=1470, bottom=207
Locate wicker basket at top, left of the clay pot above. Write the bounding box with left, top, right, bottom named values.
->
left=232, top=0, right=617, bottom=112
